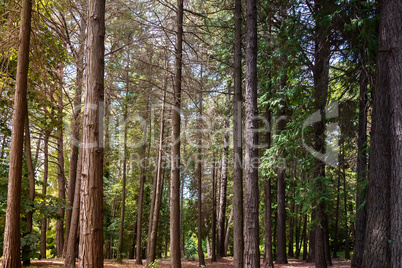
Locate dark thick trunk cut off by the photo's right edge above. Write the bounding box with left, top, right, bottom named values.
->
left=388, top=0, right=402, bottom=267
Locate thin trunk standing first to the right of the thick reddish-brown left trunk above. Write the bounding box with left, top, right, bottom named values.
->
left=117, top=97, right=128, bottom=262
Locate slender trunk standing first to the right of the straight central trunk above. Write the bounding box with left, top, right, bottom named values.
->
left=197, top=92, right=205, bottom=267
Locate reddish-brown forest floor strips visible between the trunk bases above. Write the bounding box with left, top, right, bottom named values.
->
left=8, top=258, right=350, bottom=268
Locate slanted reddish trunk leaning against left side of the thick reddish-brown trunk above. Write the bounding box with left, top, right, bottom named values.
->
left=64, top=151, right=82, bottom=268
